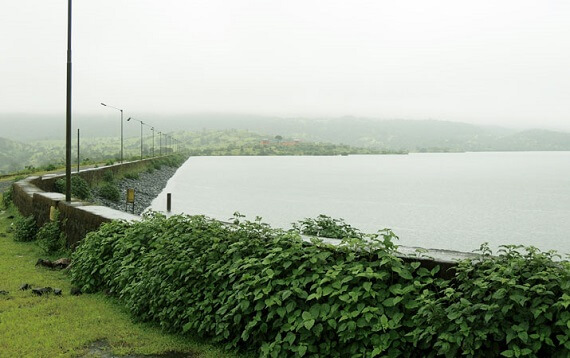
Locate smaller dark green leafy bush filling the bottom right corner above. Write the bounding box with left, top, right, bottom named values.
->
left=412, top=245, right=570, bottom=357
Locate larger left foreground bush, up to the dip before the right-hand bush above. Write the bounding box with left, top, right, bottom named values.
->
left=72, top=214, right=432, bottom=357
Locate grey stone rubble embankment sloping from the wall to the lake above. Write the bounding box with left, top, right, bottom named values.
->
left=92, top=166, right=178, bottom=215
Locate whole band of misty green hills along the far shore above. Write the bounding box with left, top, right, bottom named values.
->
left=0, top=114, right=570, bottom=173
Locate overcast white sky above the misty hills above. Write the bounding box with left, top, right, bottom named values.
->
left=0, top=0, right=570, bottom=130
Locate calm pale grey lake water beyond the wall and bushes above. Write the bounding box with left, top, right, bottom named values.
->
left=151, top=152, right=570, bottom=253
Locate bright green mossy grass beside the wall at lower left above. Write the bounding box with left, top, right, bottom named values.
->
left=0, top=197, right=232, bottom=357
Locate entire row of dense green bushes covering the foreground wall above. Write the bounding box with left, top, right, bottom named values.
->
left=72, top=214, right=570, bottom=357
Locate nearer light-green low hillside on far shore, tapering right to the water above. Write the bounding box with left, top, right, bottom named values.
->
left=0, top=130, right=405, bottom=175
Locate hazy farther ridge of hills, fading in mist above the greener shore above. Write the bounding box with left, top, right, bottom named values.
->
left=155, top=115, right=570, bottom=152
